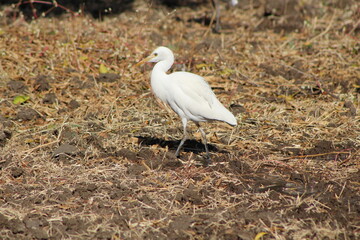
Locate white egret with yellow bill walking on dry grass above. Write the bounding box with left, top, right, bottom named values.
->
left=136, top=47, right=237, bottom=158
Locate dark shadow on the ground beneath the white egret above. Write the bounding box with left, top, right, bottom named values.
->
left=135, top=136, right=227, bottom=154
